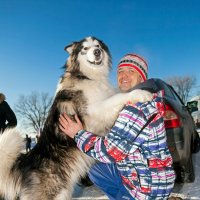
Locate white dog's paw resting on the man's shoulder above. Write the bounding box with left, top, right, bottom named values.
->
left=129, top=89, right=153, bottom=103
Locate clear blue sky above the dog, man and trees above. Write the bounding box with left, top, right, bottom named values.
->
left=0, top=0, right=200, bottom=107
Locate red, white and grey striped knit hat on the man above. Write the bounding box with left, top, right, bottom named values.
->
left=117, top=53, right=148, bottom=81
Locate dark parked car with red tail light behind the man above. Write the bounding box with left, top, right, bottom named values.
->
left=136, top=79, right=197, bottom=183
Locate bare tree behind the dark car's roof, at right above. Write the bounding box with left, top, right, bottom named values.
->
left=166, top=76, right=196, bottom=103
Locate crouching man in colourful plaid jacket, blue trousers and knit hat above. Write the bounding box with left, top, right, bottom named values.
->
left=59, top=54, right=175, bottom=200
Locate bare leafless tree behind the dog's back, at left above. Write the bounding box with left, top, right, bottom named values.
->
left=14, top=92, right=53, bottom=132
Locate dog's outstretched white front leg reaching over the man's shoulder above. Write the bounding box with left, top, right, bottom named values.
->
left=86, top=89, right=153, bottom=135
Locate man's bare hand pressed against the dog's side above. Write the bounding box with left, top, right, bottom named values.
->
left=59, top=113, right=83, bottom=138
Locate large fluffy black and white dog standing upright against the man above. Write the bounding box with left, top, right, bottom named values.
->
left=0, top=37, right=152, bottom=200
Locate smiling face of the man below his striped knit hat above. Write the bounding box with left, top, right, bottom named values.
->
left=117, top=66, right=143, bottom=92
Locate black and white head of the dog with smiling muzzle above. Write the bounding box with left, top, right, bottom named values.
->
left=65, top=37, right=111, bottom=78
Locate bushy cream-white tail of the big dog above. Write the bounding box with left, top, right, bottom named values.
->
left=0, top=128, right=24, bottom=199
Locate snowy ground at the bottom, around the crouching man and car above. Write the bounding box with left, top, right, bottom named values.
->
left=73, top=152, right=200, bottom=200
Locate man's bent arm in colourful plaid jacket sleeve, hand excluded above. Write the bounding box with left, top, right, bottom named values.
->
left=75, top=106, right=148, bottom=163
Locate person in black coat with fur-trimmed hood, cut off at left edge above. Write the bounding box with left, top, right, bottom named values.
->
left=0, top=93, right=17, bottom=134
